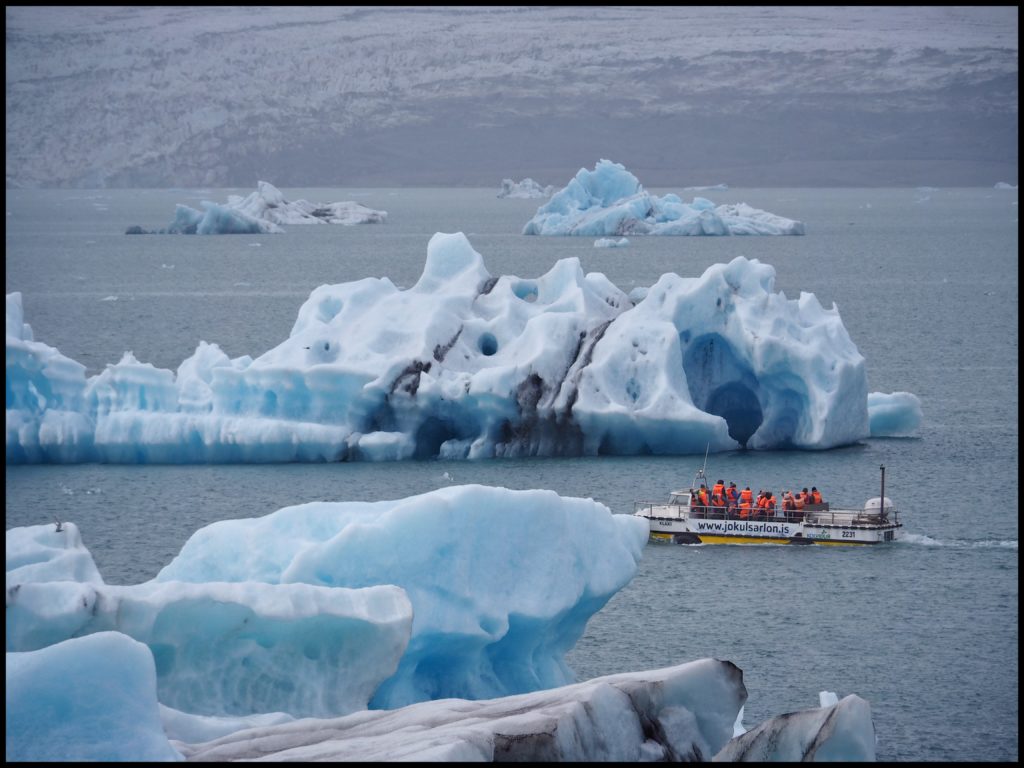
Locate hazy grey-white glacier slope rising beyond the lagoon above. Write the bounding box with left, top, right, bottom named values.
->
left=6, top=6, right=1018, bottom=187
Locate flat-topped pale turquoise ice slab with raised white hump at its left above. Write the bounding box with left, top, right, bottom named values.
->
left=6, top=523, right=413, bottom=717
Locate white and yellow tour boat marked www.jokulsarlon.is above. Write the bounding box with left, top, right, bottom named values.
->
left=634, top=459, right=902, bottom=546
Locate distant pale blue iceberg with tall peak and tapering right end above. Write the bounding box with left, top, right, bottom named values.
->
left=522, top=160, right=804, bottom=237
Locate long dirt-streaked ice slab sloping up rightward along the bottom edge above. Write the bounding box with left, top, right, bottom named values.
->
left=179, top=658, right=746, bottom=763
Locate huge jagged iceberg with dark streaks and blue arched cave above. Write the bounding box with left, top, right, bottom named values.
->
left=6, top=232, right=920, bottom=464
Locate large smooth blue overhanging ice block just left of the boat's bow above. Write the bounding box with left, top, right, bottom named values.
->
left=155, top=485, right=648, bottom=709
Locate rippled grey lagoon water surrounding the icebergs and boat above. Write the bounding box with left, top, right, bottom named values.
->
left=5, top=186, right=1019, bottom=762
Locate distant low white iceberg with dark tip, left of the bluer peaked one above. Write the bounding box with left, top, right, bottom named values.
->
left=125, top=181, right=387, bottom=234
